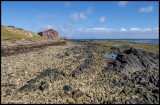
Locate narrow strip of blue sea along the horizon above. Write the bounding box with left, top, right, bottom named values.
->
left=67, top=39, right=159, bottom=45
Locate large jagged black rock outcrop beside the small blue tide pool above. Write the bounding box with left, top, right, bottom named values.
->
left=102, top=47, right=159, bottom=73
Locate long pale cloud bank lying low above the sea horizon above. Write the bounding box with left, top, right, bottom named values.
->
left=62, top=27, right=159, bottom=39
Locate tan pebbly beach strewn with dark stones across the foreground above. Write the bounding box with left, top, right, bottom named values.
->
left=1, top=39, right=159, bottom=104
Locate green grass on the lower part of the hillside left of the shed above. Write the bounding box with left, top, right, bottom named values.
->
left=1, top=27, right=46, bottom=41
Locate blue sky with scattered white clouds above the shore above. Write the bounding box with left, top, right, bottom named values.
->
left=1, top=1, right=159, bottom=39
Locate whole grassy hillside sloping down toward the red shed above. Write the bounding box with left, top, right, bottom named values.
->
left=1, top=25, right=46, bottom=41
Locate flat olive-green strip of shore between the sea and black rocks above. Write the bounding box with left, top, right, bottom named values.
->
left=92, top=41, right=159, bottom=53
